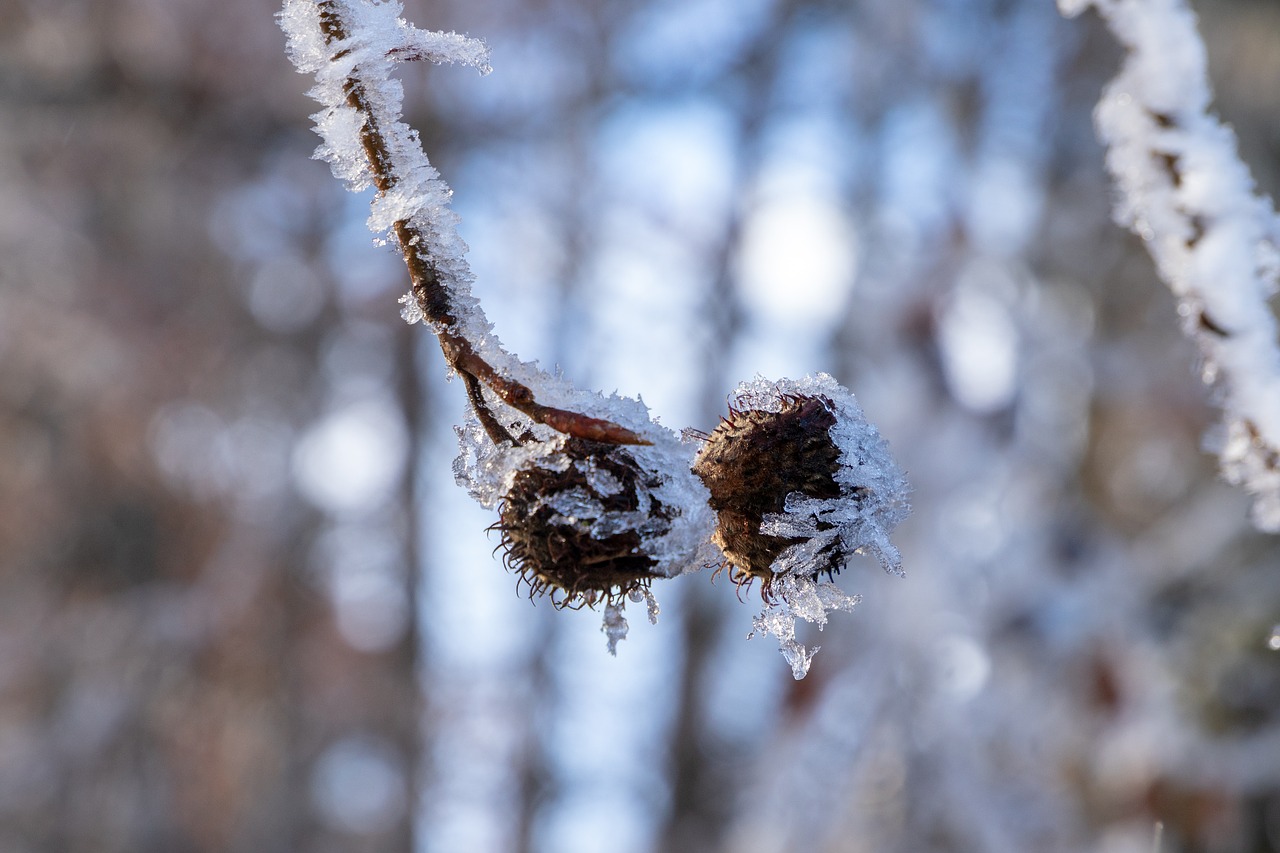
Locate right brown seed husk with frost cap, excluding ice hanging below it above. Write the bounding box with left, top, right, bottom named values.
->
left=694, top=374, right=908, bottom=598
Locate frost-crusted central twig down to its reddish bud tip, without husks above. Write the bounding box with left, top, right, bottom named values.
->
left=280, top=0, right=648, bottom=444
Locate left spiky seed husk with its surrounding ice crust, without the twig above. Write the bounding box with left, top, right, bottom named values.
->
left=453, top=365, right=713, bottom=649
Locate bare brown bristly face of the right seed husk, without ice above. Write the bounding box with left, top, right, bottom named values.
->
left=694, top=394, right=847, bottom=598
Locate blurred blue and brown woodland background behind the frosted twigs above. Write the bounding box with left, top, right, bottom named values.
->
left=0, top=0, right=1280, bottom=853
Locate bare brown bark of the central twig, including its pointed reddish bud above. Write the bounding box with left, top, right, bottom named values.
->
left=311, top=0, right=649, bottom=444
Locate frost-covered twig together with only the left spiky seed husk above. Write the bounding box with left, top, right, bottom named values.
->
left=280, top=0, right=710, bottom=651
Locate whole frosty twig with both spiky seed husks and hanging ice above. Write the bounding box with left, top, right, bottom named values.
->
left=280, top=0, right=908, bottom=678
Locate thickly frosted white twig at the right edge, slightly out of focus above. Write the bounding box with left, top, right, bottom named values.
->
left=1059, top=0, right=1280, bottom=532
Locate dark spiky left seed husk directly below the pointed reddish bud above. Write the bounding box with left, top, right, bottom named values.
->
left=494, top=438, right=676, bottom=607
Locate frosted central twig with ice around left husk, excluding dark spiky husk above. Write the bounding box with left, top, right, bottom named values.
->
left=280, top=0, right=710, bottom=651
